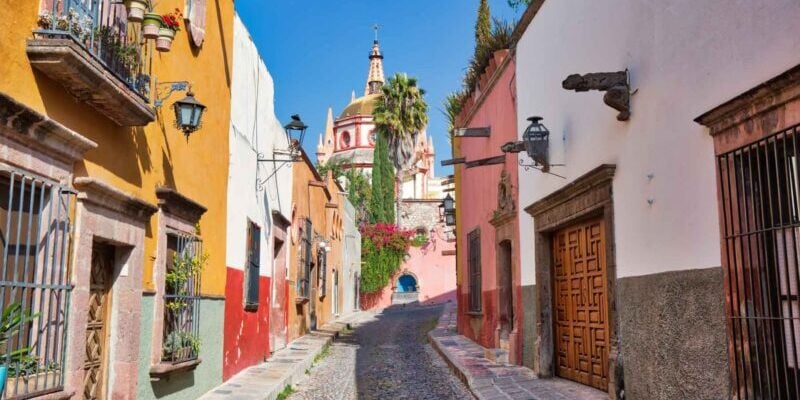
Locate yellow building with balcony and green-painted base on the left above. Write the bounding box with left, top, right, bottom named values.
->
left=0, top=0, right=234, bottom=399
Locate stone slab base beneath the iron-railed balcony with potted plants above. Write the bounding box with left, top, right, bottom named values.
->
left=27, top=38, right=156, bottom=126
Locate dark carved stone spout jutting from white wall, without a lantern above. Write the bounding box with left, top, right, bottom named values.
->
left=561, top=69, right=631, bottom=121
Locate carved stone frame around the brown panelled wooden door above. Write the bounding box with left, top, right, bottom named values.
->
left=525, top=164, right=622, bottom=399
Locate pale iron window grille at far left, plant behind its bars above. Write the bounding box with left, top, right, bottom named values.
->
left=0, top=167, right=75, bottom=399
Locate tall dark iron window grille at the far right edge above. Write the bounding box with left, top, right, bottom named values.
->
left=717, top=126, right=800, bottom=399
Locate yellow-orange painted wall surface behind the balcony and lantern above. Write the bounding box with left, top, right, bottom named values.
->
left=0, top=0, right=234, bottom=296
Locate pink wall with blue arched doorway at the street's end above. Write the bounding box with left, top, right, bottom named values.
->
left=361, top=226, right=456, bottom=310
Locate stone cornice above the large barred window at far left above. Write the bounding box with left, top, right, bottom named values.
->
left=0, top=92, right=97, bottom=164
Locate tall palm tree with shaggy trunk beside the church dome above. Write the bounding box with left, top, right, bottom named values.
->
left=372, top=74, right=428, bottom=223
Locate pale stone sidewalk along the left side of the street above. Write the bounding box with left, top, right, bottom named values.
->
left=200, top=312, right=368, bottom=400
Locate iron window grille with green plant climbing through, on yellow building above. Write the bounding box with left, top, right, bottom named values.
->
left=161, top=233, right=205, bottom=363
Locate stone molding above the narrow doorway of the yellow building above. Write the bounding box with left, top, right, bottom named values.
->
left=74, top=176, right=158, bottom=222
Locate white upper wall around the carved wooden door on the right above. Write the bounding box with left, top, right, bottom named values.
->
left=516, top=0, right=800, bottom=284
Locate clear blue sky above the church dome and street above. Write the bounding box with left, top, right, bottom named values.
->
left=235, top=0, right=522, bottom=175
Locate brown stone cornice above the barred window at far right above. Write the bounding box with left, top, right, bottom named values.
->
left=694, top=65, right=800, bottom=136
